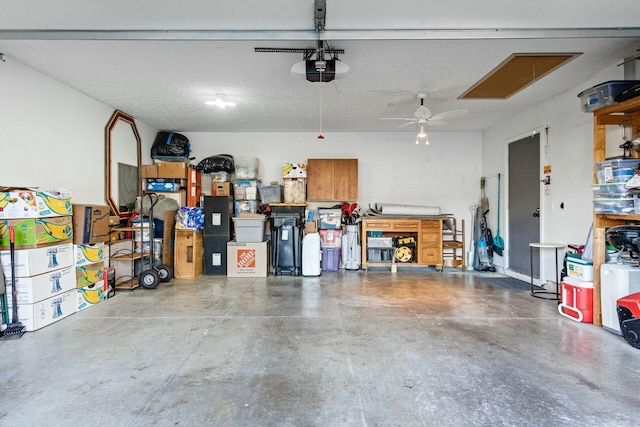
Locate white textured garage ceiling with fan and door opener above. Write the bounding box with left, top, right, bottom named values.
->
left=0, top=0, right=640, bottom=132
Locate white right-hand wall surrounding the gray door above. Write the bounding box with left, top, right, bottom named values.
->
left=482, top=65, right=623, bottom=281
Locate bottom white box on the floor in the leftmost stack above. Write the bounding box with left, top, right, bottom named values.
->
left=9, top=289, right=78, bottom=331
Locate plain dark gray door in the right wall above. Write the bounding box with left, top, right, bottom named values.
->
left=507, top=134, right=540, bottom=277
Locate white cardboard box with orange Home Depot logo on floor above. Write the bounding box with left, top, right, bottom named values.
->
left=227, top=242, right=268, bottom=277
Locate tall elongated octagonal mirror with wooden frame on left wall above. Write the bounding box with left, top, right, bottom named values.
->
left=105, top=110, right=141, bottom=218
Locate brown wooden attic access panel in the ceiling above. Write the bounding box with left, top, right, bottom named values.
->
left=458, top=53, right=582, bottom=99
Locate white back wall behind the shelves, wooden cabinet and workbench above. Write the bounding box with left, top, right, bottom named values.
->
left=185, top=132, right=482, bottom=227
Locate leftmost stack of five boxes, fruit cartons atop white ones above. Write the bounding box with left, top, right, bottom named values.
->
left=0, top=187, right=76, bottom=331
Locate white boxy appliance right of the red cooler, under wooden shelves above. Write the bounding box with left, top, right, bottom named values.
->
left=600, top=264, right=640, bottom=335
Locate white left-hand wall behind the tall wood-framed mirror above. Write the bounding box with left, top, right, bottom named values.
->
left=0, top=57, right=156, bottom=204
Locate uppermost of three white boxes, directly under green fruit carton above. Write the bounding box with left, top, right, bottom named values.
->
left=0, top=243, right=74, bottom=277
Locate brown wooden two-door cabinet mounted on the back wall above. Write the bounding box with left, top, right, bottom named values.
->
left=307, top=159, right=358, bottom=202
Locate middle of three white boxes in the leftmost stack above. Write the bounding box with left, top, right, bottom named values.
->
left=7, top=267, right=76, bottom=304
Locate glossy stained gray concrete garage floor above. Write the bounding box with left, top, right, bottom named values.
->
left=0, top=269, right=640, bottom=427
